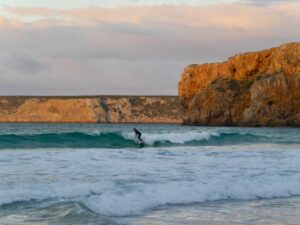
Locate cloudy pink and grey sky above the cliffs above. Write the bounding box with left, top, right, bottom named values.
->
left=0, top=0, right=300, bottom=95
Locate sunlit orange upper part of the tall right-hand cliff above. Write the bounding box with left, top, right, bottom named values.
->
left=178, top=42, right=300, bottom=101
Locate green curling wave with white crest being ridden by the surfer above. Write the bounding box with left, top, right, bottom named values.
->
left=0, top=131, right=284, bottom=149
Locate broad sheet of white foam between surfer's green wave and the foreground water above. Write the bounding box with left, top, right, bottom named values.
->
left=0, top=145, right=300, bottom=216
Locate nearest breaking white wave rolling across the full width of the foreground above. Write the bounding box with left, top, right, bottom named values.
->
left=0, top=175, right=300, bottom=216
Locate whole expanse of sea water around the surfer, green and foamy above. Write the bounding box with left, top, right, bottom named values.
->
left=0, top=124, right=300, bottom=225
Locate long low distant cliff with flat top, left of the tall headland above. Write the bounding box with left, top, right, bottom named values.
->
left=0, top=96, right=182, bottom=123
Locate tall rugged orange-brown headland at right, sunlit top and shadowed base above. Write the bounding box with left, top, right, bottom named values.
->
left=178, top=43, right=300, bottom=126
